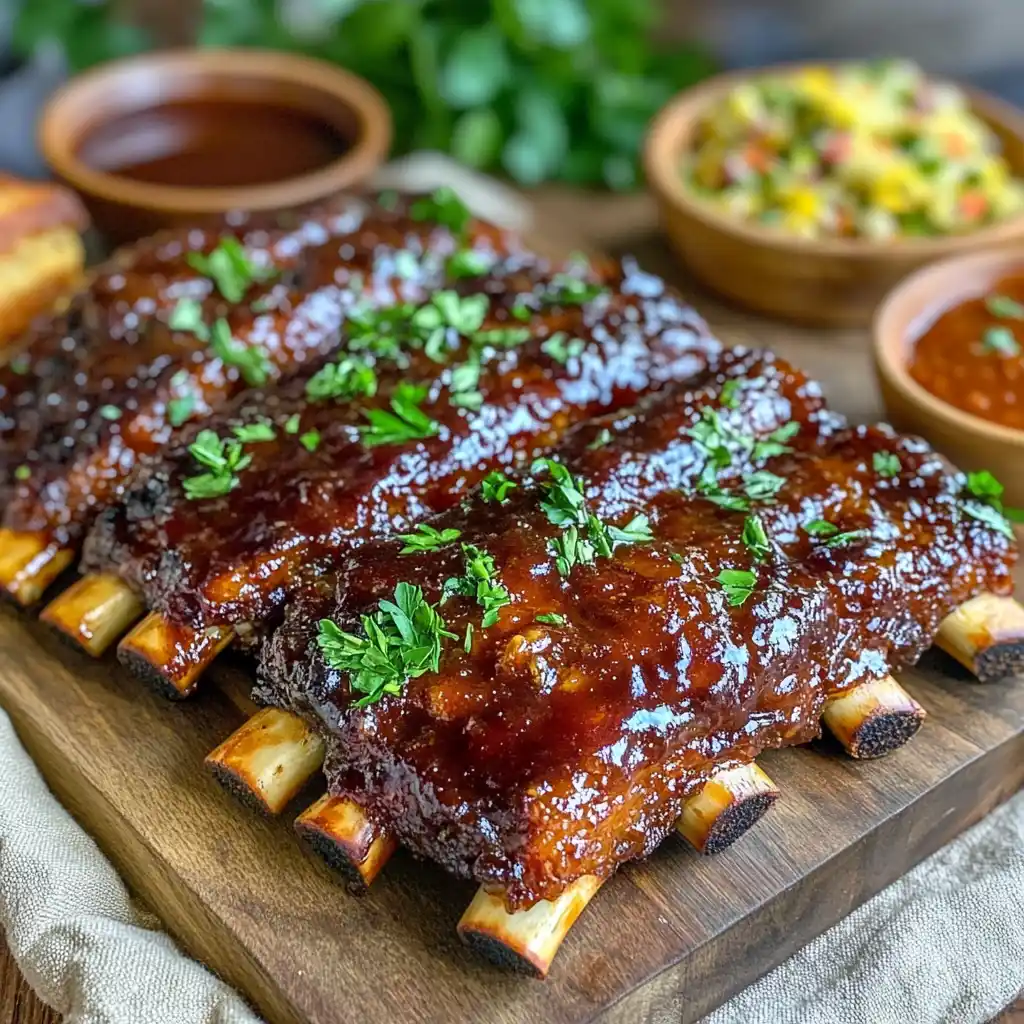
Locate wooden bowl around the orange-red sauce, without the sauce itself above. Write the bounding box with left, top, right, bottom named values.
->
left=874, top=246, right=1024, bottom=507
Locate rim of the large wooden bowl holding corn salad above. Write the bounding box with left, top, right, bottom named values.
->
left=643, top=60, right=1024, bottom=261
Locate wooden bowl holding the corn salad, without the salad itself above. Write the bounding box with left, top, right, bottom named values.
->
left=644, top=65, right=1024, bottom=325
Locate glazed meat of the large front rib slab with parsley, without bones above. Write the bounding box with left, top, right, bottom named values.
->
left=253, top=387, right=1015, bottom=962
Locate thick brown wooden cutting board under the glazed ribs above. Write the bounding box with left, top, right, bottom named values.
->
left=0, top=193, right=1024, bottom=1024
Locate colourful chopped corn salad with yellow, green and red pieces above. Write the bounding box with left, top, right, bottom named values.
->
left=683, top=61, right=1024, bottom=241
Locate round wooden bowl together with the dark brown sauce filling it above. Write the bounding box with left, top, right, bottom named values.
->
left=40, top=50, right=391, bottom=241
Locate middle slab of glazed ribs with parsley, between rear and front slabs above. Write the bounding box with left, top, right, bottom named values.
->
left=74, top=252, right=724, bottom=695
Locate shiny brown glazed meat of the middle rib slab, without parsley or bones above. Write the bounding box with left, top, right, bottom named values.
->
left=85, top=263, right=722, bottom=629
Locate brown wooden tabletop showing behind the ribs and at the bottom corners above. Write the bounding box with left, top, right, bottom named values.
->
left=0, top=188, right=1024, bottom=1024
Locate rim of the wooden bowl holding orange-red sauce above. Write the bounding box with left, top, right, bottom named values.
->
left=872, top=246, right=1024, bottom=449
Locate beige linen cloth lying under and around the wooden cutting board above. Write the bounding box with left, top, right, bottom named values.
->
left=0, top=154, right=1024, bottom=1024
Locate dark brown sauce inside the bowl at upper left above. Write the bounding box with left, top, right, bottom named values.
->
left=79, top=99, right=350, bottom=188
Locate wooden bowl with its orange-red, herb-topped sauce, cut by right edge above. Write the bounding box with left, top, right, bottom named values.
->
left=874, top=247, right=1024, bottom=506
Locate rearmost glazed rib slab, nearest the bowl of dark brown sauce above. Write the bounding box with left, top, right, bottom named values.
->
left=0, top=191, right=527, bottom=604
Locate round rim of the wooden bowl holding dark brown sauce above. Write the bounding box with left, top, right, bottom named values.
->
left=39, top=48, right=392, bottom=214
